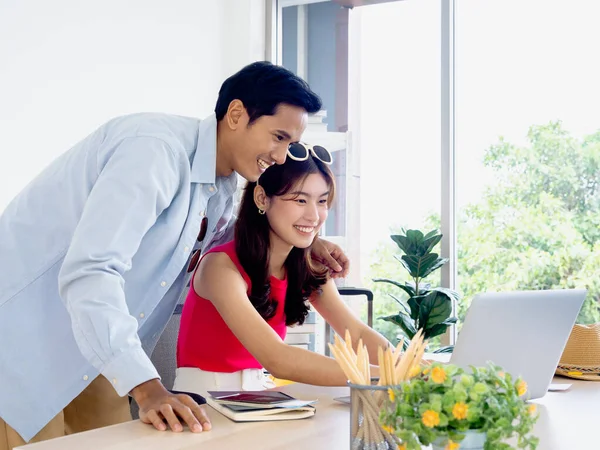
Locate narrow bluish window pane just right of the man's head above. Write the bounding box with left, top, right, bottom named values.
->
left=280, top=1, right=348, bottom=237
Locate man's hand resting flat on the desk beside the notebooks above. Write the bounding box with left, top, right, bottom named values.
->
left=131, top=379, right=211, bottom=433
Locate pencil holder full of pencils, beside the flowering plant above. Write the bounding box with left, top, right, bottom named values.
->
left=348, top=380, right=400, bottom=450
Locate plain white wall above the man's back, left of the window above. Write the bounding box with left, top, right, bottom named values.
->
left=0, top=0, right=265, bottom=212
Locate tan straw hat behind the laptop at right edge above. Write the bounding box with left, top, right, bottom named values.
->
left=556, top=323, right=600, bottom=381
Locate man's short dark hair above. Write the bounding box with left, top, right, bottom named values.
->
left=215, top=61, right=322, bottom=124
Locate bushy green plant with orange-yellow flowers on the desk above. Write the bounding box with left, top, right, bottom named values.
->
left=380, top=363, right=538, bottom=450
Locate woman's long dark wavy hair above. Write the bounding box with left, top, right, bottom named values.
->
left=235, top=155, right=335, bottom=325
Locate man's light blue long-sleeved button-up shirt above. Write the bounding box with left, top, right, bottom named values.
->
left=0, top=113, right=237, bottom=440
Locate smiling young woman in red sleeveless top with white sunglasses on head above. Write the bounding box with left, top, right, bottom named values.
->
left=174, top=143, right=389, bottom=395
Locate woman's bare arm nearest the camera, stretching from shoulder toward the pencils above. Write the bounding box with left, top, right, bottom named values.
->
left=193, top=253, right=347, bottom=386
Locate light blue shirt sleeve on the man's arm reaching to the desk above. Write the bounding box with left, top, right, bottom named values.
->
left=58, top=137, right=180, bottom=396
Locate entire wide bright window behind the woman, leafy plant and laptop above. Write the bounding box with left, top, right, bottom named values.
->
left=274, top=0, right=600, bottom=346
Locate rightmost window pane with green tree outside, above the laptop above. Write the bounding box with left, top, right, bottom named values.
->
left=455, top=0, right=600, bottom=322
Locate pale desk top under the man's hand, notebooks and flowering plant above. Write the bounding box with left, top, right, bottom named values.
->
left=19, top=377, right=600, bottom=450
